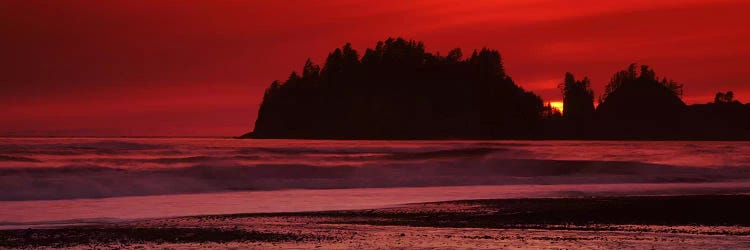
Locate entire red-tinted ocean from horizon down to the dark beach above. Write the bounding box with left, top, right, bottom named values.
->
left=0, top=138, right=750, bottom=228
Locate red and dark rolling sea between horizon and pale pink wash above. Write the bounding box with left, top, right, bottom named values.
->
left=0, top=139, right=750, bottom=201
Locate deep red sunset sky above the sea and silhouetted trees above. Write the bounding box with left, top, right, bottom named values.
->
left=0, top=0, right=750, bottom=136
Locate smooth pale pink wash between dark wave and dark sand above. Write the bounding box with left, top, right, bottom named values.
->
left=0, top=182, right=750, bottom=228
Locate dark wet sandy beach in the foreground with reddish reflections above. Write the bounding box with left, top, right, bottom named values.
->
left=0, top=195, right=750, bottom=248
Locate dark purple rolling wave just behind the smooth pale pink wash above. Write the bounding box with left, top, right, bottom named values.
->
left=0, top=159, right=750, bottom=201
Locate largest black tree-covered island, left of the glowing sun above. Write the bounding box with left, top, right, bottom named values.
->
left=248, top=38, right=543, bottom=139
